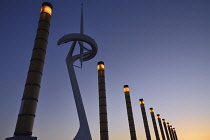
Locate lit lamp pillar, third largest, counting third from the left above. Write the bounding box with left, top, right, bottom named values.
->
left=124, top=85, right=137, bottom=140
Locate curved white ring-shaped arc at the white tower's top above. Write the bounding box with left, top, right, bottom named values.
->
left=57, top=33, right=98, bottom=61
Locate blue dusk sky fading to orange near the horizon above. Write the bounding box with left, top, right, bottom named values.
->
left=0, top=0, right=210, bottom=140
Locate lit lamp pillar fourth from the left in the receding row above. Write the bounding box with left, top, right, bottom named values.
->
left=139, top=99, right=151, bottom=140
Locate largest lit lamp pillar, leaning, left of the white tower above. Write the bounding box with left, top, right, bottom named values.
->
left=7, top=2, right=53, bottom=140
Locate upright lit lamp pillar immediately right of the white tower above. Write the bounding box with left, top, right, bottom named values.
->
left=98, top=61, right=109, bottom=140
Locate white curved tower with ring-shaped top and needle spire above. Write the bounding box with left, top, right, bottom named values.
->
left=57, top=5, right=98, bottom=140
